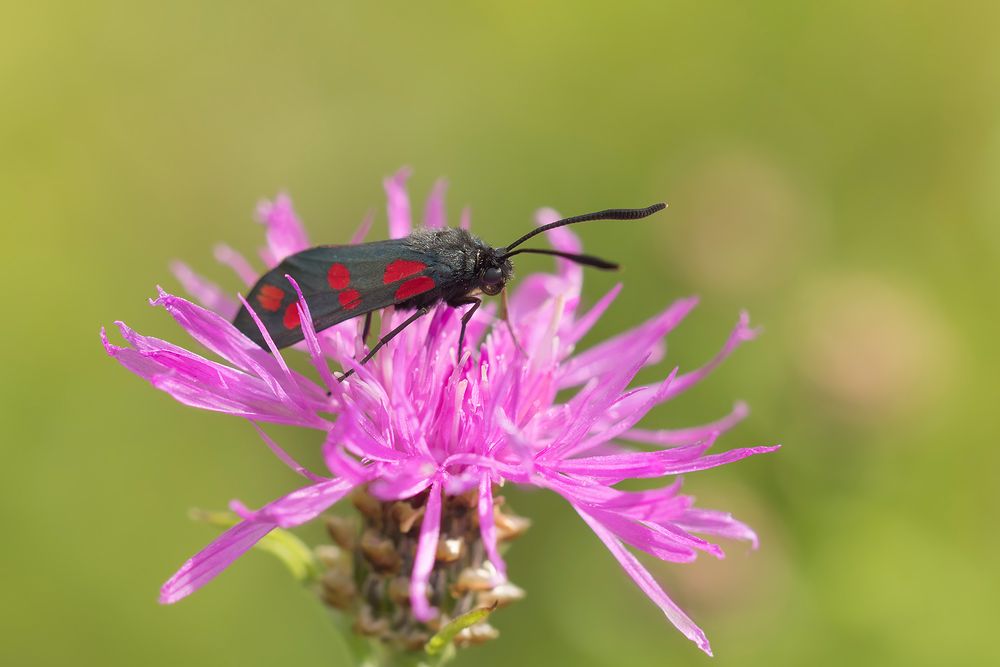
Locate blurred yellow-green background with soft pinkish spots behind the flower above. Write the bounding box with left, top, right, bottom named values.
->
left=0, top=0, right=1000, bottom=665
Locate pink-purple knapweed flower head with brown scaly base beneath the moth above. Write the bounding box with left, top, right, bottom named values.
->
left=102, top=171, right=776, bottom=653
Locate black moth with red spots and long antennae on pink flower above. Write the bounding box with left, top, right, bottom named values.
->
left=233, top=204, right=666, bottom=380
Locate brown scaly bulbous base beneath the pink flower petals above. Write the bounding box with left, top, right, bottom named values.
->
left=317, top=490, right=529, bottom=651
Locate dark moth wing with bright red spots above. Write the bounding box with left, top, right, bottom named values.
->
left=233, top=239, right=442, bottom=349
